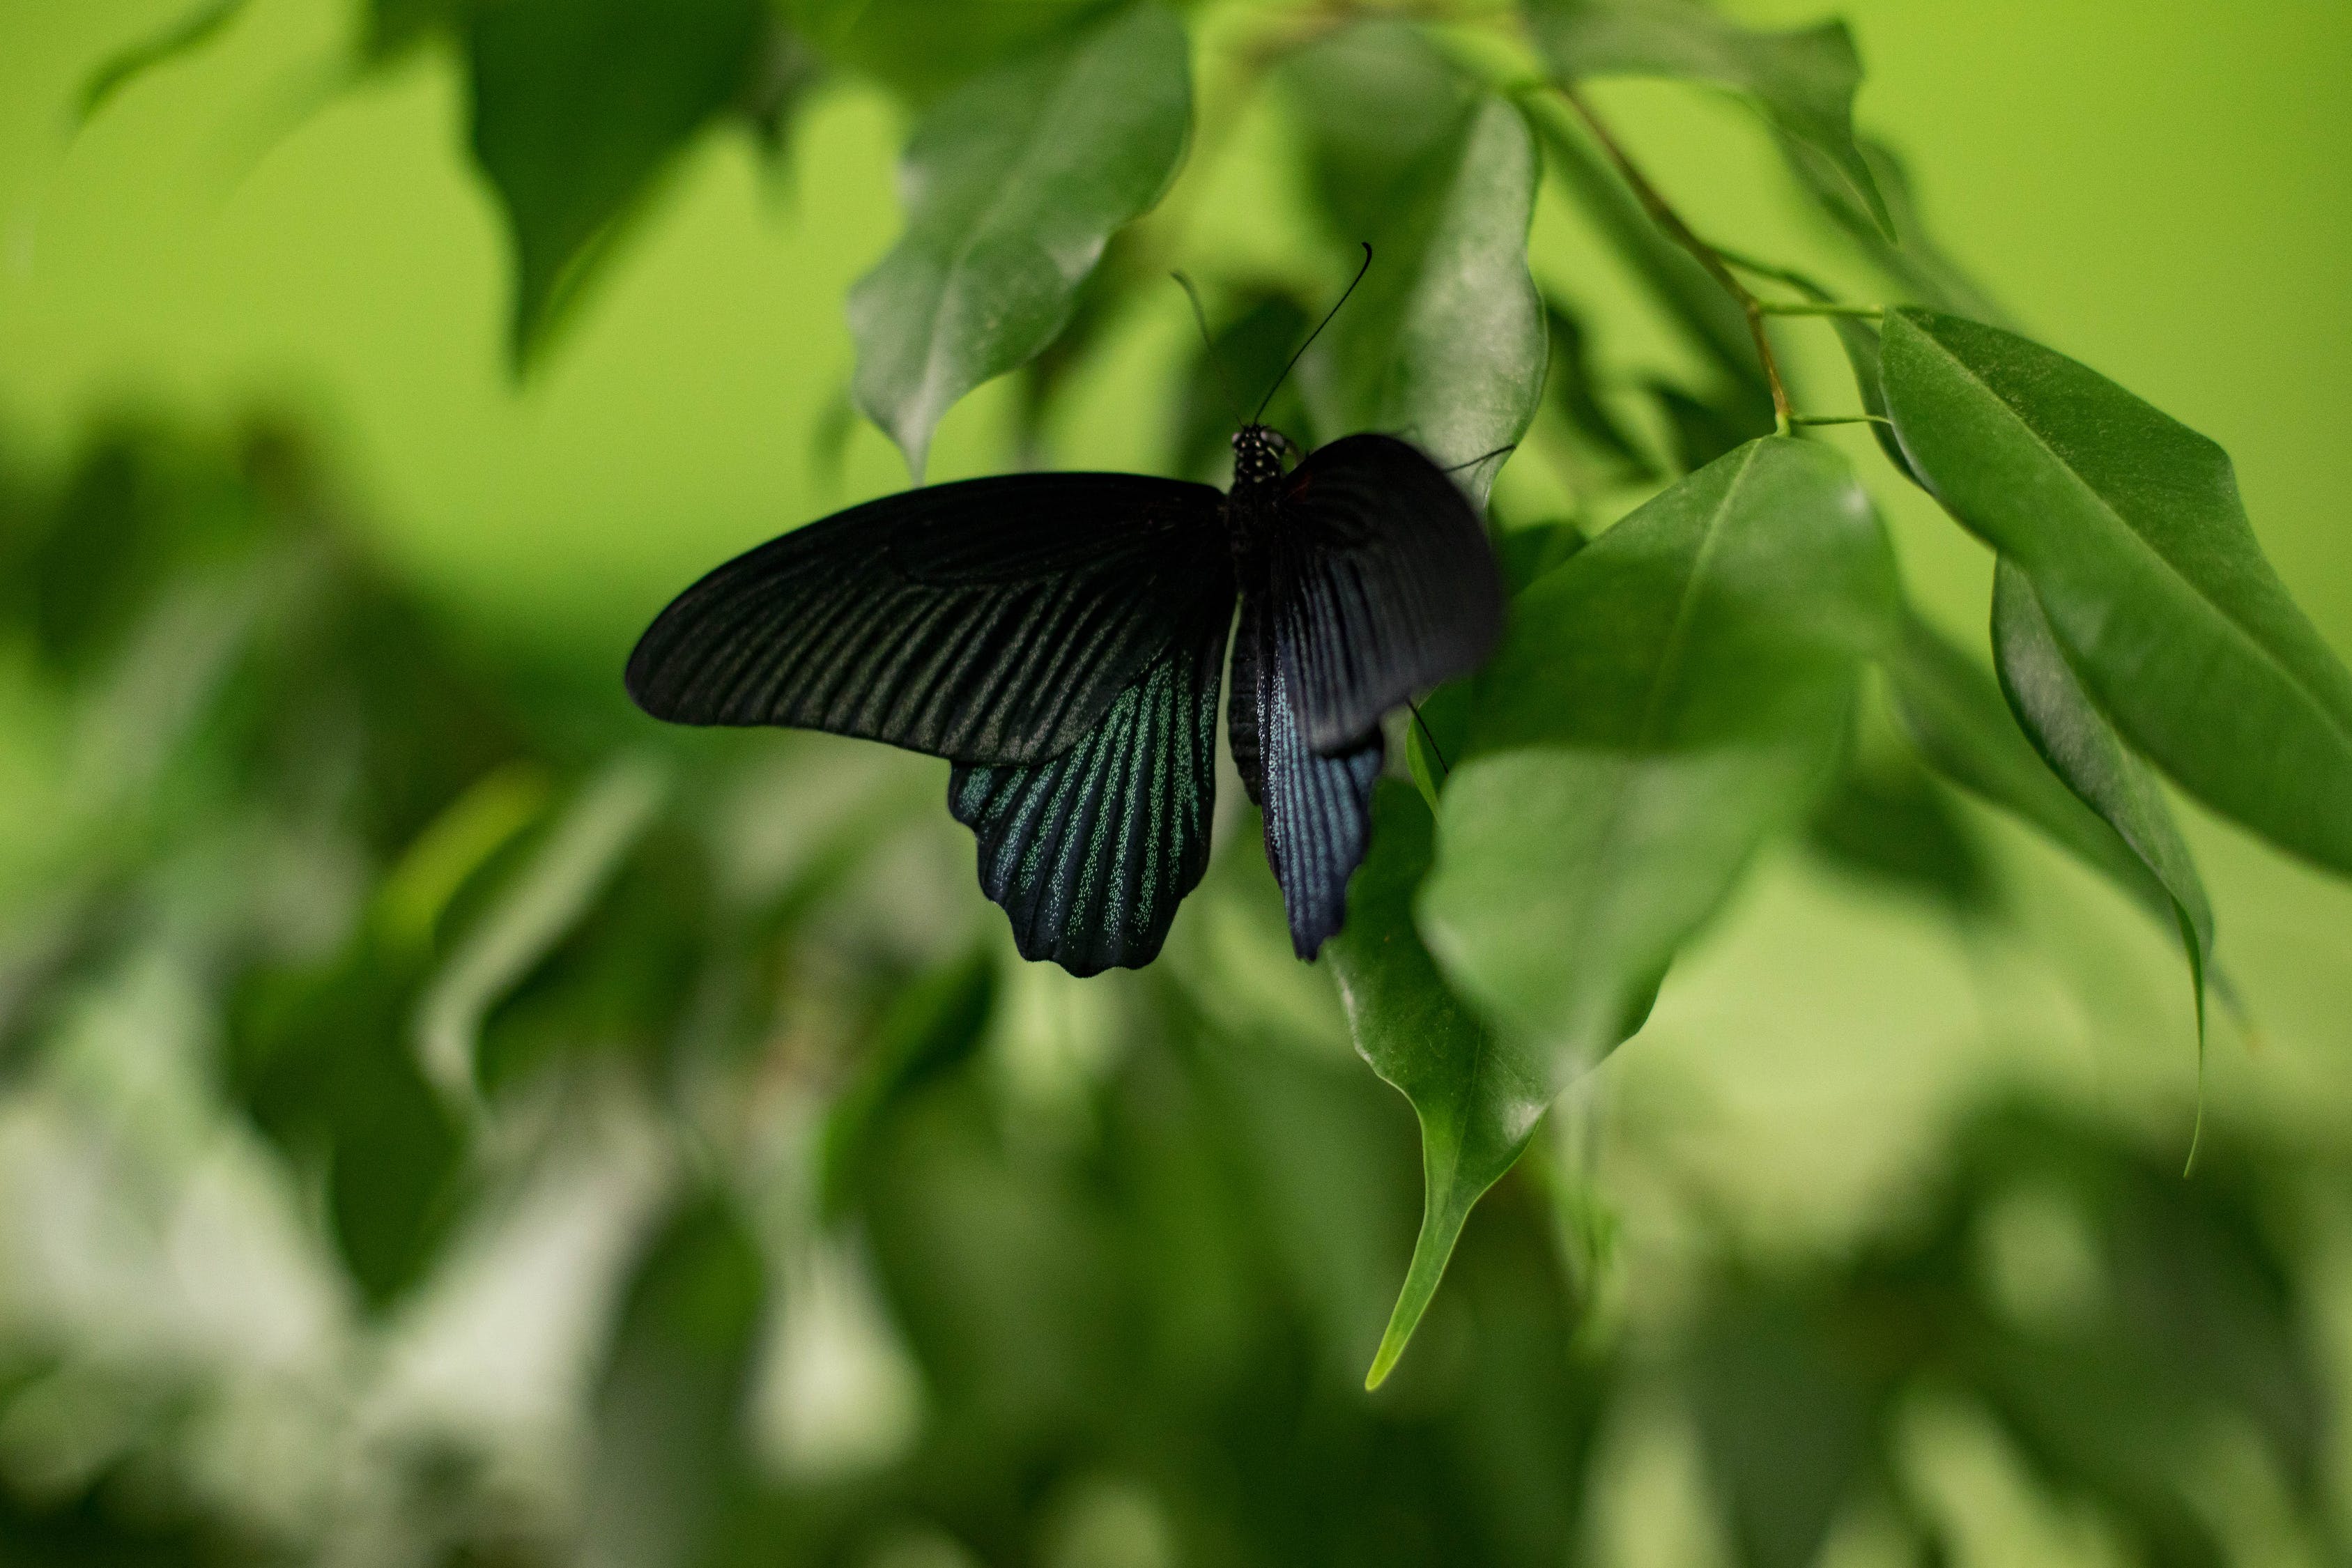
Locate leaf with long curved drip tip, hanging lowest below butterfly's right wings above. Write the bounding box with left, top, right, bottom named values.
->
left=1331, top=778, right=1553, bottom=1390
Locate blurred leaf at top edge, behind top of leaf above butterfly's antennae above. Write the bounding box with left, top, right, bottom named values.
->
left=1284, top=21, right=1473, bottom=247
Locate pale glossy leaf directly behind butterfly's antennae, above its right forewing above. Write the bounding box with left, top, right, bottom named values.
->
left=1303, top=99, right=1548, bottom=505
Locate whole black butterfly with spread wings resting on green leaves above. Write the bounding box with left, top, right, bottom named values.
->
left=626, top=247, right=1503, bottom=976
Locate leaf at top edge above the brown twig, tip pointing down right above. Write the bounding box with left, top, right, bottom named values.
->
left=1531, top=0, right=1896, bottom=240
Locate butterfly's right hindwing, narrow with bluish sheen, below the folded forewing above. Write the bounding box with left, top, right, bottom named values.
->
left=1230, top=599, right=1383, bottom=959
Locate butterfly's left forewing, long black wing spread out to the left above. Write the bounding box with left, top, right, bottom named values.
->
left=628, top=472, right=1230, bottom=764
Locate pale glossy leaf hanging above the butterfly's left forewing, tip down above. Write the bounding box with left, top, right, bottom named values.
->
left=849, top=5, right=1192, bottom=479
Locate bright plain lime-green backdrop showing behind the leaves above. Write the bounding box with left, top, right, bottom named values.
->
left=0, top=0, right=2352, bottom=1551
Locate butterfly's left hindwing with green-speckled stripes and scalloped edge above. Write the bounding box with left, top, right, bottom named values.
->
left=948, top=585, right=1233, bottom=976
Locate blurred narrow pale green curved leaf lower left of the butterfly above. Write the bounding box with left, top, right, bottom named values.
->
left=416, top=757, right=666, bottom=1105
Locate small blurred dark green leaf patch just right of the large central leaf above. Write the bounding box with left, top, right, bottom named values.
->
left=1806, top=757, right=1999, bottom=919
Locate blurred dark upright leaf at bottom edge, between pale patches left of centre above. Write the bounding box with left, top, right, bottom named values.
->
left=578, top=1197, right=767, bottom=1568
